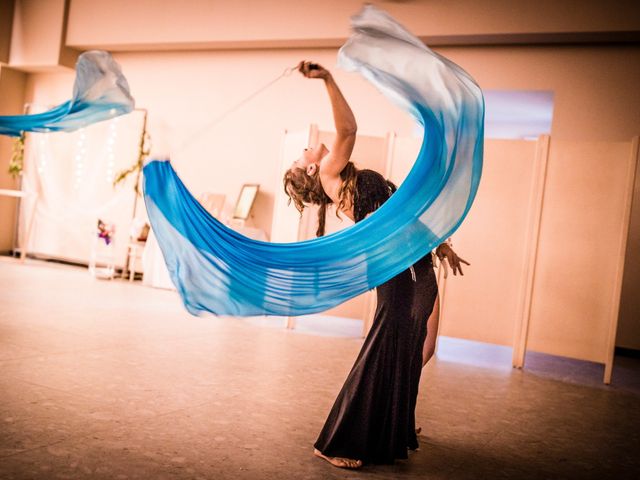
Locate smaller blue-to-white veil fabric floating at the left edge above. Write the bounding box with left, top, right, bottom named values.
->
left=0, top=50, right=134, bottom=137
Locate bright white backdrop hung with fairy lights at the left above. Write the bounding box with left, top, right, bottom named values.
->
left=23, top=112, right=144, bottom=270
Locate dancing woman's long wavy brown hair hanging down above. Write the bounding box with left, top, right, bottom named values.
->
left=283, top=162, right=358, bottom=237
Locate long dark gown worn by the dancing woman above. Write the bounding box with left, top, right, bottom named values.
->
left=314, top=170, right=438, bottom=464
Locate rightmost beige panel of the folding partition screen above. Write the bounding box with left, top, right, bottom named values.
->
left=528, top=140, right=630, bottom=363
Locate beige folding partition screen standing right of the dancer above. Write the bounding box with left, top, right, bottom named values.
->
left=391, top=136, right=638, bottom=383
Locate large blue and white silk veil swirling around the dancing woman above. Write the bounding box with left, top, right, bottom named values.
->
left=144, top=6, right=484, bottom=316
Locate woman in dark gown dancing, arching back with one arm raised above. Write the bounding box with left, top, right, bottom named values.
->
left=284, top=62, right=469, bottom=468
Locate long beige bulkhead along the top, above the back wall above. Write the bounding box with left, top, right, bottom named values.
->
left=67, top=0, right=640, bottom=50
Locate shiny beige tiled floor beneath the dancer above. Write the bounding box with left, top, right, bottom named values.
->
left=0, top=259, right=640, bottom=479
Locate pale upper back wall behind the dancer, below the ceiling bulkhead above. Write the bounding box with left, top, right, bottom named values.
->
left=21, top=43, right=640, bottom=231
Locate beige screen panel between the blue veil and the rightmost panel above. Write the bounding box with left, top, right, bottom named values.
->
left=440, top=140, right=536, bottom=346
